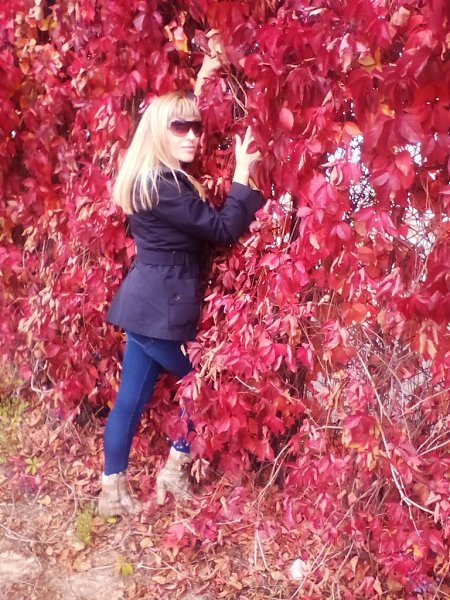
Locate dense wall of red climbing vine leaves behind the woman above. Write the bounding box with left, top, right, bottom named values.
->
left=0, top=0, right=450, bottom=597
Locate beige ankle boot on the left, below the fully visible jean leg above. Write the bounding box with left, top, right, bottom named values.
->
left=98, top=471, right=142, bottom=519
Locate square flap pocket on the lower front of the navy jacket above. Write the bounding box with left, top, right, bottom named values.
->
left=167, top=279, right=200, bottom=327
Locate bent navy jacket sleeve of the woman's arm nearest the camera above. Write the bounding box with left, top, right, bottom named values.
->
left=151, top=178, right=264, bottom=245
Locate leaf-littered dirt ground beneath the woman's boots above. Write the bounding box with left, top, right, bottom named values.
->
left=0, top=406, right=320, bottom=600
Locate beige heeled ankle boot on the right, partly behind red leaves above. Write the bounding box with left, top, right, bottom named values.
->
left=156, top=446, right=192, bottom=504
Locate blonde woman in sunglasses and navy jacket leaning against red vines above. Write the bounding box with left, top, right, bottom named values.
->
left=99, top=59, right=263, bottom=517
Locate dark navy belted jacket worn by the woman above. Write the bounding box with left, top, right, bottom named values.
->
left=106, top=171, right=264, bottom=341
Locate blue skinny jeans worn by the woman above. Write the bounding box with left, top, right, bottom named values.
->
left=104, top=332, right=192, bottom=475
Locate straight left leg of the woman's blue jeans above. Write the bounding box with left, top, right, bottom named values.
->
left=104, top=336, right=162, bottom=475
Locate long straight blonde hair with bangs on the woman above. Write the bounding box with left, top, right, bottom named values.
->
left=113, top=90, right=205, bottom=214
